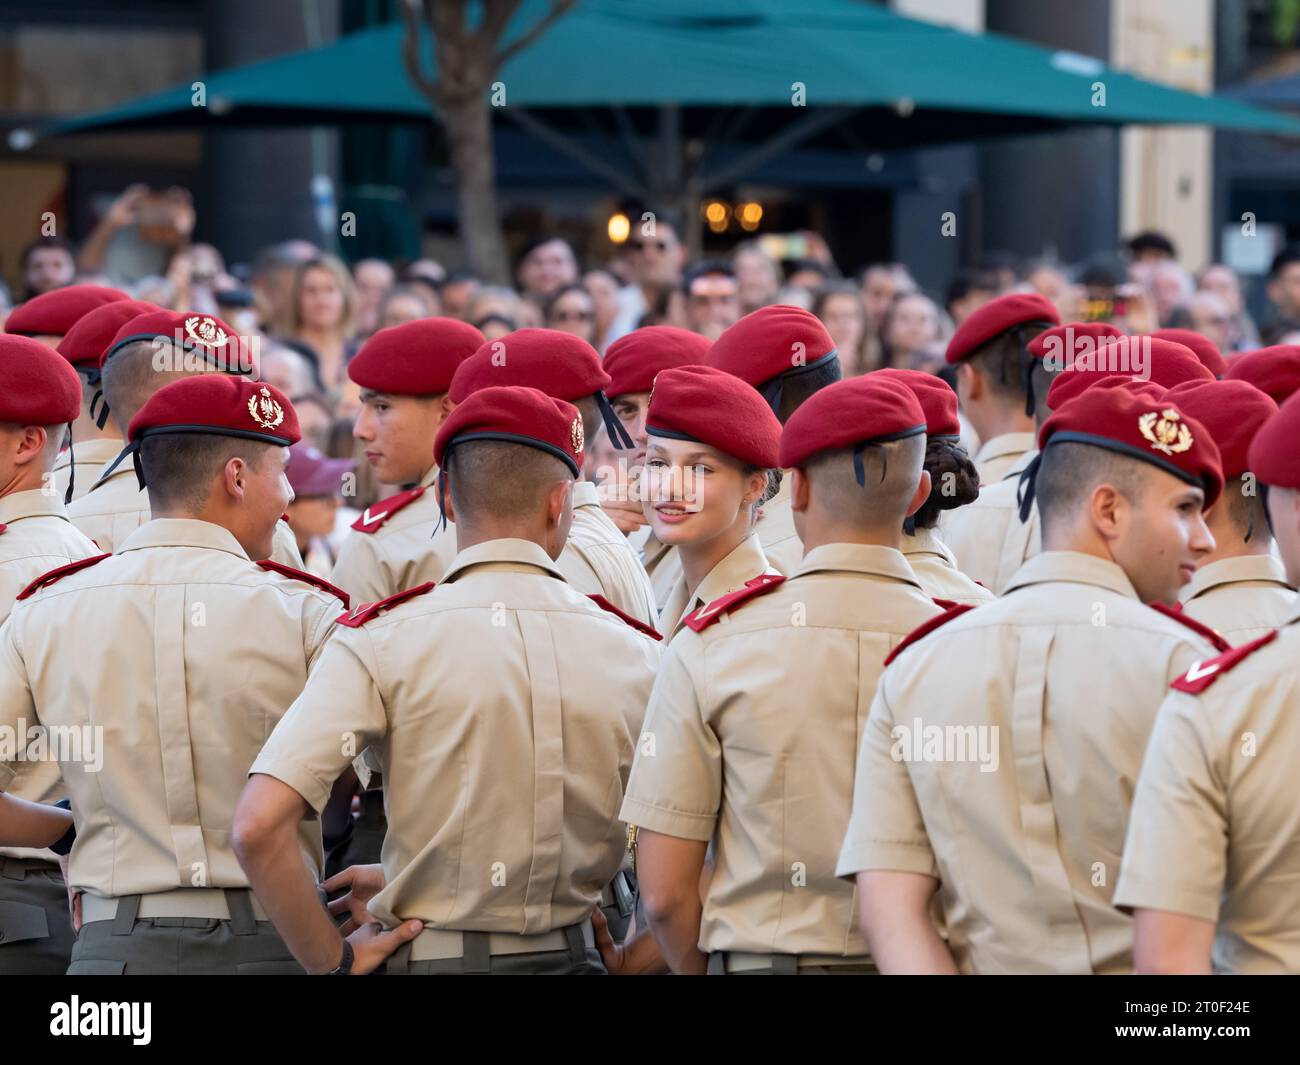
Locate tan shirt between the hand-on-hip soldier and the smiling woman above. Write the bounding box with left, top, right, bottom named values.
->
left=558, top=481, right=659, bottom=628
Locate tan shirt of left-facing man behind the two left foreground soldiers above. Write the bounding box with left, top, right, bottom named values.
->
left=330, top=466, right=456, bottom=606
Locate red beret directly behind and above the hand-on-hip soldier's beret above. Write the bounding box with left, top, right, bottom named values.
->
left=450, top=329, right=610, bottom=403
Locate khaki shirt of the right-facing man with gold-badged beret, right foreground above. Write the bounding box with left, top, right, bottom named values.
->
left=839, top=551, right=1214, bottom=974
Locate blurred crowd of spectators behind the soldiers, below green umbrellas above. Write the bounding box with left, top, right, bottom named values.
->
left=0, top=186, right=1300, bottom=576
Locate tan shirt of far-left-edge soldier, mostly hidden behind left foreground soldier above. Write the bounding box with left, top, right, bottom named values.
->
left=0, top=488, right=100, bottom=861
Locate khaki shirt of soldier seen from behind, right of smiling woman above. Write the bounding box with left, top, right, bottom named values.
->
left=623, top=544, right=940, bottom=957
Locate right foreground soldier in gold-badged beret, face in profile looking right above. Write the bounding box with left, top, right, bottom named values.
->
left=839, top=385, right=1226, bottom=973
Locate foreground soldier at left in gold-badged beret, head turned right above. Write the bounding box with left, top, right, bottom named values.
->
left=0, top=375, right=346, bottom=974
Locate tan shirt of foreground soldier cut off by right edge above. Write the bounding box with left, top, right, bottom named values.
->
left=1115, top=609, right=1300, bottom=974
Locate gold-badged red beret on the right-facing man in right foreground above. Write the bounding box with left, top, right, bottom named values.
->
left=1022, top=386, right=1223, bottom=514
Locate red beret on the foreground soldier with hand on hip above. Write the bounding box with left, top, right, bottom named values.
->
left=433, top=384, right=584, bottom=477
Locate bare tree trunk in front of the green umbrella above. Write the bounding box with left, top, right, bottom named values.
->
left=442, top=92, right=511, bottom=285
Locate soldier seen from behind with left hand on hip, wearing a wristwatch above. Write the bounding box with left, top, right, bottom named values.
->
left=234, top=388, right=658, bottom=974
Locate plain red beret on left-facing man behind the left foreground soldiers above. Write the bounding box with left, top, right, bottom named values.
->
left=347, top=319, right=484, bottom=395
